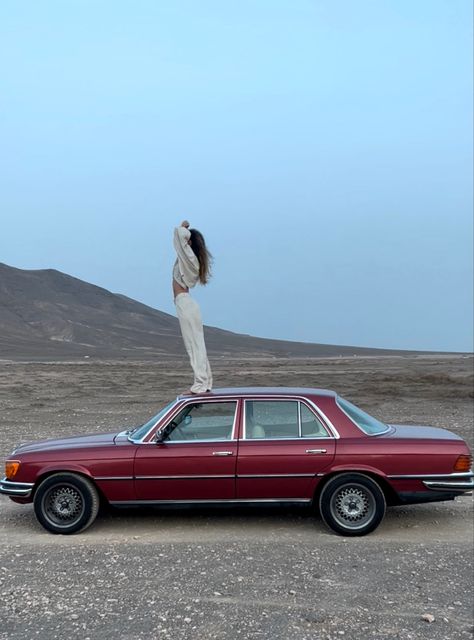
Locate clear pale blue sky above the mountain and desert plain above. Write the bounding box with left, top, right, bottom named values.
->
left=0, top=0, right=473, bottom=351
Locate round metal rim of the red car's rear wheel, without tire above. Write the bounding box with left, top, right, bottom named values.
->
left=330, top=483, right=376, bottom=530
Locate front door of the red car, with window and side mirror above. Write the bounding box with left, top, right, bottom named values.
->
left=135, top=399, right=238, bottom=502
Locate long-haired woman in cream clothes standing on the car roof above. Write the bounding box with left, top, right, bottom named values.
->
left=173, top=220, right=212, bottom=393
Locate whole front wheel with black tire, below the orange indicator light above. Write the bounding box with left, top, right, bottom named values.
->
left=33, top=473, right=100, bottom=535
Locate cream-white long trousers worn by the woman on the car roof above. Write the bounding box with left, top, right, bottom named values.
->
left=174, top=293, right=212, bottom=393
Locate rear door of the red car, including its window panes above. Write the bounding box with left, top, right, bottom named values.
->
left=237, top=399, right=335, bottom=500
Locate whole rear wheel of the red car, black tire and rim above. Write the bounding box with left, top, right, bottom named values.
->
left=319, top=473, right=386, bottom=536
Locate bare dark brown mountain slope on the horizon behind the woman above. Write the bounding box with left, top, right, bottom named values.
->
left=0, top=263, right=408, bottom=359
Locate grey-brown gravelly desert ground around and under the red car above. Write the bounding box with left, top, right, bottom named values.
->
left=0, top=356, right=474, bottom=640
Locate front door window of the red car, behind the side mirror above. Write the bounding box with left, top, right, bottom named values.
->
left=165, top=402, right=237, bottom=442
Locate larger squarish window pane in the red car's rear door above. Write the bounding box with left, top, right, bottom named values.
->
left=245, top=400, right=299, bottom=440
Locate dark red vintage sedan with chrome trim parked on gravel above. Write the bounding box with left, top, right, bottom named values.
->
left=0, top=387, right=474, bottom=536
